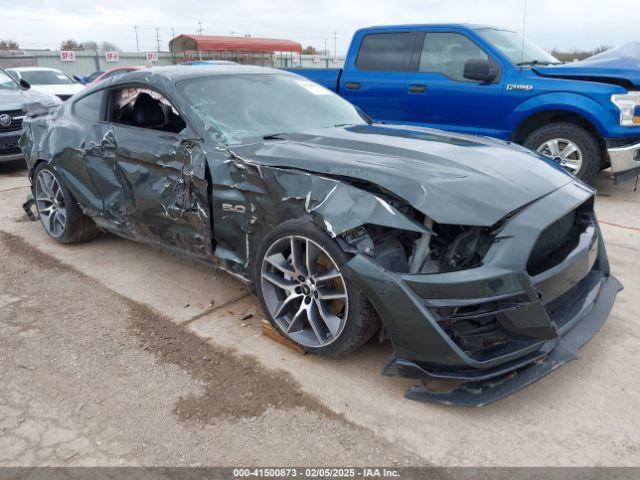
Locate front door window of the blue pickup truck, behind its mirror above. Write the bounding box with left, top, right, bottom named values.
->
left=418, top=32, right=497, bottom=82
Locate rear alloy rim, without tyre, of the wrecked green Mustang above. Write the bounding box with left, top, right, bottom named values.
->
left=36, top=169, right=67, bottom=238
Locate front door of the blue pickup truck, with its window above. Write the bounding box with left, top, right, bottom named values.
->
left=406, top=31, right=502, bottom=136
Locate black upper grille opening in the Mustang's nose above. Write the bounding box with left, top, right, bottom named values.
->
left=527, top=199, right=593, bottom=276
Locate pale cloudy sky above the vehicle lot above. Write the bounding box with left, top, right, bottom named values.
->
left=0, top=0, right=640, bottom=55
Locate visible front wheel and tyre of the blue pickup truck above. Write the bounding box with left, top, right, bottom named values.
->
left=524, top=122, right=603, bottom=185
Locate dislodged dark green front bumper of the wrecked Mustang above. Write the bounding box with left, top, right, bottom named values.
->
left=347, top=182, right=621, bottom=406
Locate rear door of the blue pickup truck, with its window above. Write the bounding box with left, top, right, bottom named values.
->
left=338, top=31, right=416, bottom=122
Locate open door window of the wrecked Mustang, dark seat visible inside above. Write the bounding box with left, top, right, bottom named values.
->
left=108, top=87, right=186, bottom=133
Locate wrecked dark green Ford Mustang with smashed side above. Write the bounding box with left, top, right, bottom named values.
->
left=21, top=65, right=621, bottom=406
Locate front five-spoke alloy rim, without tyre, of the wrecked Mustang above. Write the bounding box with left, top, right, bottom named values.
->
left=260, top=235, right=349, bottom=348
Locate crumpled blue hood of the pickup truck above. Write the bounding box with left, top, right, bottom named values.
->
left=534, top=42, right=640, bottom=88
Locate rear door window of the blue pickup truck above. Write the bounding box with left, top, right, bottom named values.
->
left=356, top=33, right=413, bottom=72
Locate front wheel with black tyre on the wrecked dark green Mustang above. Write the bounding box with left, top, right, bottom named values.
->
left=255, top=220, right=379, bottom=356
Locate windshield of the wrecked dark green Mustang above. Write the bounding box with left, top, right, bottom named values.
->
left=182, top=74, right=367, bottom=144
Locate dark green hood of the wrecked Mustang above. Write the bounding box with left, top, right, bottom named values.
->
left=231, top=125, right=573, bottom=226
